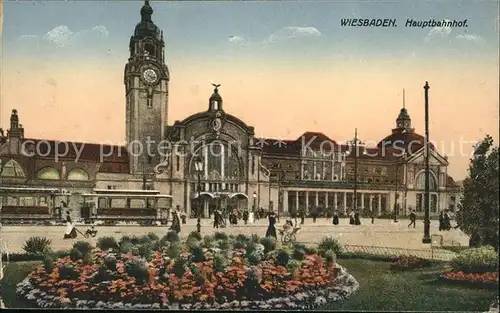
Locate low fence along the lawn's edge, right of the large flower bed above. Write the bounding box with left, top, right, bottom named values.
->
left=344, top=245, right=456, bottom=261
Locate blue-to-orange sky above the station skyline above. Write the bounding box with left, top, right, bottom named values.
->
left=0, top=0, right=499, bottom=180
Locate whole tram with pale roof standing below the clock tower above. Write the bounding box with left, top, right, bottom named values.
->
left=80, top=189, right=172, bottom=222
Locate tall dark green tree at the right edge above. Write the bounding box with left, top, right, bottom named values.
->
left=457, top=135, right=500, bottom=250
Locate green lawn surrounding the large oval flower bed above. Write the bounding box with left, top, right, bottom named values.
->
left=2, top=259, right=497, bottom=311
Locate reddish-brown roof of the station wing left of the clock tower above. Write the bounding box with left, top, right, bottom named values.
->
left=24, top=139, right=130, bottom=174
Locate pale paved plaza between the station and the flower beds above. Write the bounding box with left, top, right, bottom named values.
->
left=3, top=218, right=469, bottom=253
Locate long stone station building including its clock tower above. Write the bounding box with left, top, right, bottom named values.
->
left=0, top=0, right=460, bottom=217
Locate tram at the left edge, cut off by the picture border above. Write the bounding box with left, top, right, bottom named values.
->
left=0, top=187, right=70, bottom=224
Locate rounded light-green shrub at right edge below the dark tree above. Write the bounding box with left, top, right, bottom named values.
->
left=451, top=246, right=498, bottom=273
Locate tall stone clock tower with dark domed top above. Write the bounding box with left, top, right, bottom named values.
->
left=124, top=0, right=170, bottom=174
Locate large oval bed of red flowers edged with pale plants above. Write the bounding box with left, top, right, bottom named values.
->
left=17, top=234, right=359, bottom=309
